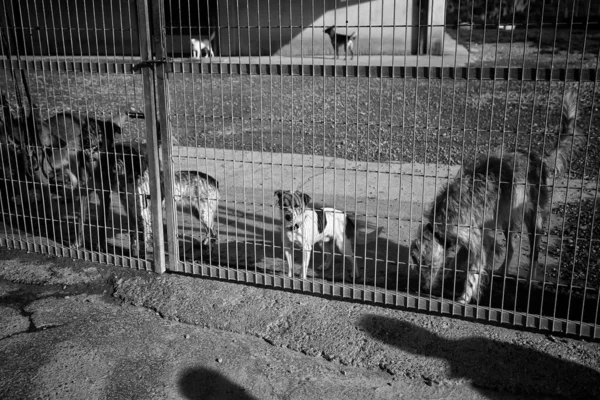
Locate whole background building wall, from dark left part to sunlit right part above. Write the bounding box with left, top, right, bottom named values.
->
left=5, top=0, right=432, bottom=57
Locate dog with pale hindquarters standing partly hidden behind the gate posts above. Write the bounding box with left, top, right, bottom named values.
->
left=105, top=144, right=220, bottom=255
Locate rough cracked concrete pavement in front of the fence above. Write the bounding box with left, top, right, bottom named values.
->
left=0, top=250, right=600, bottom=399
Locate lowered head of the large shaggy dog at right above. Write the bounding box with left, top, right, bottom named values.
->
left=410, top=222, right=448, bottom=291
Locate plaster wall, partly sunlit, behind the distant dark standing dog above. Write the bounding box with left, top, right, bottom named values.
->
left=218, top=0, right=418, bottom=56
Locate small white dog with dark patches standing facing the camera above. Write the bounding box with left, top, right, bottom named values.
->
left=275, top=190, right=360, bottom=279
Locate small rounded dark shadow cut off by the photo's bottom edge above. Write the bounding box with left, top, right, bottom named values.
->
left=178, top=367, right=255, bottom=400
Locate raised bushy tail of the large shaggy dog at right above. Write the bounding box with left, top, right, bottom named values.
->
left=544, top=92, right=587, bottom=176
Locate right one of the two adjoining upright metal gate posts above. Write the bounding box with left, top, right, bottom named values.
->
left=152, top=0, right=179, bottom=271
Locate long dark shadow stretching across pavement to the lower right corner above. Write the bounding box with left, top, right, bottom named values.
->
left=360, top=315, right=600, bottom=399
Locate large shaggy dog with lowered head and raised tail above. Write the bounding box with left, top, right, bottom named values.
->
left=411, top=93, right=586, bottom=304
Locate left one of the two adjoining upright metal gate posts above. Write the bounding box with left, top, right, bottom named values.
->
left=137, top=0, right=166, bottom=273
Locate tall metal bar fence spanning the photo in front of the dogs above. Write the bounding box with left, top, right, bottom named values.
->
left=0, top=0, right=600, bottom=338
